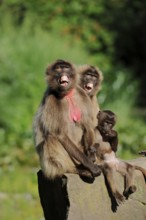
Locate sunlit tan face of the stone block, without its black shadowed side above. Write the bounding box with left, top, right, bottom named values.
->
left=37, top=157, right=146, bottom=220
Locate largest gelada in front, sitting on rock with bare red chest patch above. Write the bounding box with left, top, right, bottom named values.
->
left=33, top=60, right=101, bottom=179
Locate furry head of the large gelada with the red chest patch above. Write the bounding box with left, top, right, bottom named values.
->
left=46, top=60, right=76, bottom=92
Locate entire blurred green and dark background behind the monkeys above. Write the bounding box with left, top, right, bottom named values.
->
left=0, top=0, right=146, bottom=220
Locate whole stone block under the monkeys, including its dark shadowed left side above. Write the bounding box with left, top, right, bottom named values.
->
left=38, top=157, right=146, bottom=220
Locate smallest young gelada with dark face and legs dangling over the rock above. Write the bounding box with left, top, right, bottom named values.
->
left=95, top=110, right=146, bottom=204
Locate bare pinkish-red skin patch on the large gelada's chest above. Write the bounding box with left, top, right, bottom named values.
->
left=65, top=90, right=81, bottom=122
